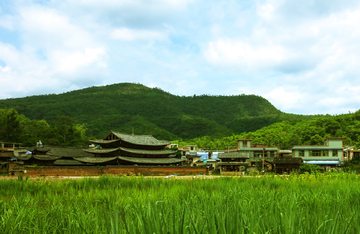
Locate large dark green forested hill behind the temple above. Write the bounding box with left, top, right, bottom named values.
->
left=0, top=83, right=316, bottom=140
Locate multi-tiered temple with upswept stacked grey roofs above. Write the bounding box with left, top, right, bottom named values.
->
left=84, top=132, right=184, bottom=165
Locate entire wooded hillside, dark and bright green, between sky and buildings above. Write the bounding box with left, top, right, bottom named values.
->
left=0, top=83, right=360, bottom=149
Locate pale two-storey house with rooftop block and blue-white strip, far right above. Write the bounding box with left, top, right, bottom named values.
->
left=292, top=137, right=344, bottom=169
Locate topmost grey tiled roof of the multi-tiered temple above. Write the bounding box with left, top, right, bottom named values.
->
left=112, top=132, right=171, bottom=146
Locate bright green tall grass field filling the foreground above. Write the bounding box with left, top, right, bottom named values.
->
left=0, top=173, right=360, bottom=233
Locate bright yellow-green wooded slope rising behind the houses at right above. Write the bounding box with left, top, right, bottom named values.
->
left=177, top=110, right=360, bottom=149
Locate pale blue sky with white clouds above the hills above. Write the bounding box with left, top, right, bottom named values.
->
left=0, top=0, right=360, bottom=114
